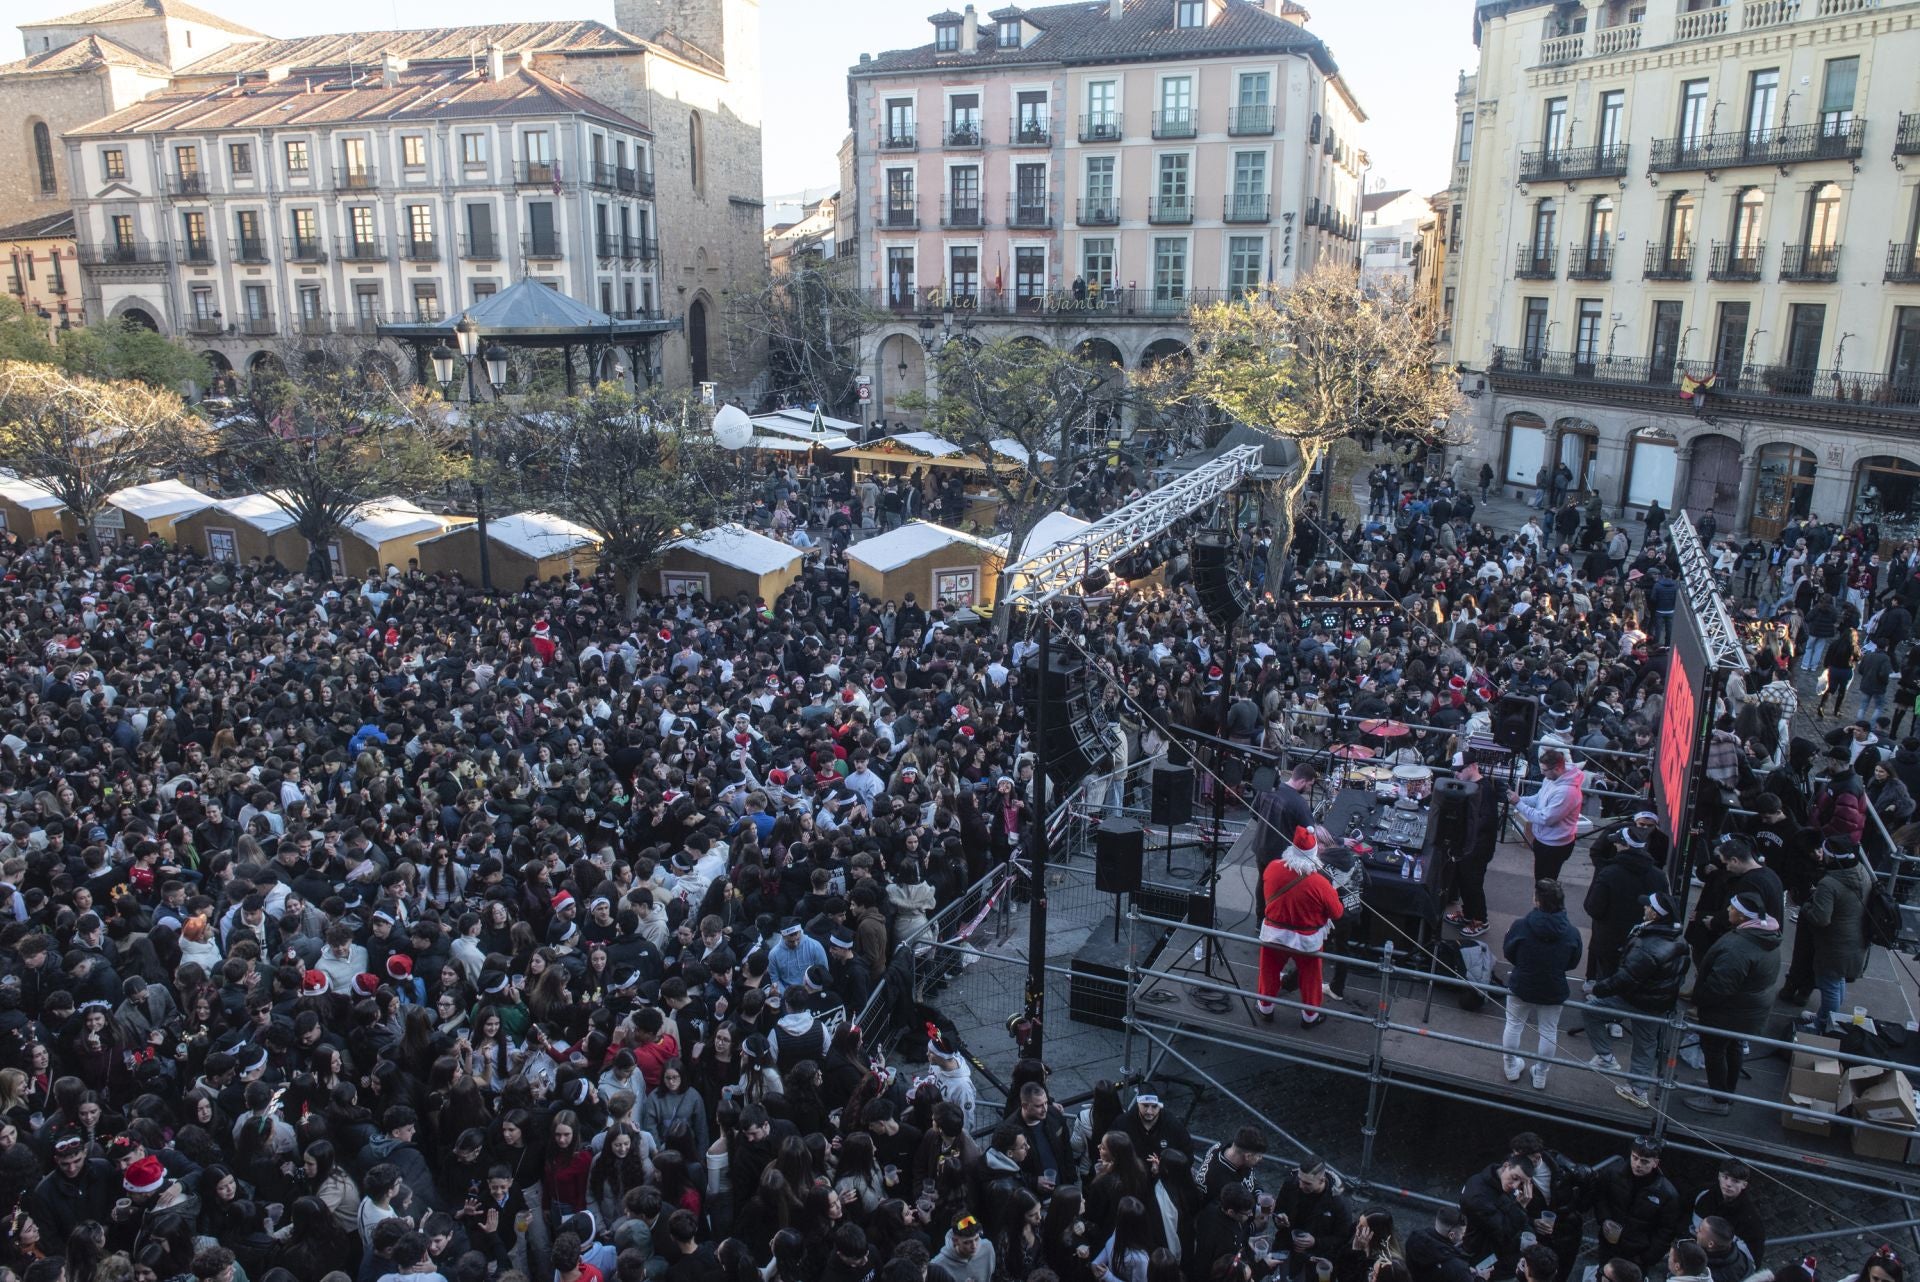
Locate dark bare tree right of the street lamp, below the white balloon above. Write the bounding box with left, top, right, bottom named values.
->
left=482, top=384, right=747, bottom=616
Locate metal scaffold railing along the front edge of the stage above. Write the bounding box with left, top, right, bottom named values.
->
left=1121, top=912, right=1920, bottom=1205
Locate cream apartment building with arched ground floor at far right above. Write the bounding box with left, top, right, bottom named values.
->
left=1442, top=0, right=1920, bottom=537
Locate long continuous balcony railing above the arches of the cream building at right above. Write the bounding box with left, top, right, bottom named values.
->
left=1486, top=347, right=1920, bottom=424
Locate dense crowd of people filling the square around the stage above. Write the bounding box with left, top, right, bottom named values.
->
left=0, top=443, right=1920, bottom=1282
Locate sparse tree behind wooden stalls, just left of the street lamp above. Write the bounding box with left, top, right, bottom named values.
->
left=219, top=347, right=463, bottom=580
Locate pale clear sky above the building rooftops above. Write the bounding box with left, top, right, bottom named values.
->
left=0, top=0, right=1475, bottom=196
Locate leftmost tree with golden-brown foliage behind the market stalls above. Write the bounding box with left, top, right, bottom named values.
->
left=0, top=361, right=205, bottom=553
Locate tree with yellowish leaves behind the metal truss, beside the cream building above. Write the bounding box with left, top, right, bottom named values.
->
left=1154, top=267, right=1459, bottom=582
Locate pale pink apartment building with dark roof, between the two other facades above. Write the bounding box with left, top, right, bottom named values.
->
left=843, top=0, right=1365, bottom=433
